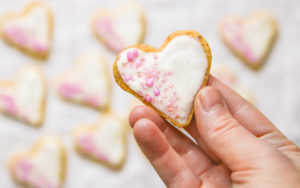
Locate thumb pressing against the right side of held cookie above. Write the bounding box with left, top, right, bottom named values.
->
left=194, top=86, right=273, bottom=170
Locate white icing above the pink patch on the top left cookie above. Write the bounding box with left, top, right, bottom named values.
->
left=3, top=6, right=50, bottom=50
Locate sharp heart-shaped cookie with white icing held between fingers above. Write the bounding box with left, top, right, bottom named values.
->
left=113, top=31, right=211, bottom=127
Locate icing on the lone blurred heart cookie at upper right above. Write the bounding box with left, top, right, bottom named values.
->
left=222, top=13, right=276, bottom=62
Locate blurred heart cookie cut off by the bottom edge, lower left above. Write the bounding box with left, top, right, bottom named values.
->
left=9, top=136, right=67, bottom=188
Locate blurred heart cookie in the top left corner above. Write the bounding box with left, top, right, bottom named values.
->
left=0, top=2, right=53, bottom=59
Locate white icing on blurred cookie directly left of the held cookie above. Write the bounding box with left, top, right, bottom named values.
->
left=58, top=53, right=110, bottom=107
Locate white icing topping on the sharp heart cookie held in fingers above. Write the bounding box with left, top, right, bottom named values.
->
left=117, top=35, right=208, bottom=124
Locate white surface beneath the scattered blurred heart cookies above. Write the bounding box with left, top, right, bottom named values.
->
left=0, top=0, right=300, bottom=188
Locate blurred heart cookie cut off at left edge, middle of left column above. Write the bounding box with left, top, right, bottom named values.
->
left=0, top=65, right=46, bottom=126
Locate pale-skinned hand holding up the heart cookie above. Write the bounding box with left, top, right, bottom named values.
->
left=129, top=76, right=300, bottom=188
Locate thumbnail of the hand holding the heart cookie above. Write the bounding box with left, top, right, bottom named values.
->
left=198, top=86, right=224, bottom=112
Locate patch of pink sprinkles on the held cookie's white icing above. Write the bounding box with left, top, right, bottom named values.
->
left=119, top=49, right=180, bottom=119
